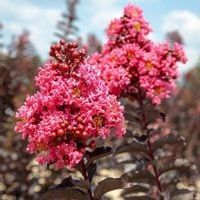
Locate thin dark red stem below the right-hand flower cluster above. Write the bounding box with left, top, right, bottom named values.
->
left=139, top=97, right=164, bottom=200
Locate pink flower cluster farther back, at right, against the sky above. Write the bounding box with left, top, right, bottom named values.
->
left=89, top=5, right=187, bottom=104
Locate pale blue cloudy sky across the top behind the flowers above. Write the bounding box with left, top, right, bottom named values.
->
left=0, top=0, right=200, bottom=73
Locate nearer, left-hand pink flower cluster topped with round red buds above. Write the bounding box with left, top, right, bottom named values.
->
left=15, top=40, right=125, bottom=168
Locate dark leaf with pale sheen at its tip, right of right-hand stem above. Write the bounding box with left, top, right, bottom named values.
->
left=158, top=159, right=191, bottom=175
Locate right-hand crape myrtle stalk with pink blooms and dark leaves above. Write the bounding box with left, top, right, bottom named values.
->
left=90, top=5, right=197, bottom=199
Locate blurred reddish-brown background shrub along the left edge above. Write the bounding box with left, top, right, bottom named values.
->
left=0, top=25, right=88, bottom=200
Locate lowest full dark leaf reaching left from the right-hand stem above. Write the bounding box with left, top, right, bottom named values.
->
left=121, top=170, right=156, bottom=185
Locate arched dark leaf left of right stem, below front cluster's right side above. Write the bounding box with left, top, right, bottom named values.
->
left=114, top=141, right=149, bottom=157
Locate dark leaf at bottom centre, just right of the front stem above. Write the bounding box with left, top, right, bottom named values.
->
left=94, top=178, right=125, bottom=199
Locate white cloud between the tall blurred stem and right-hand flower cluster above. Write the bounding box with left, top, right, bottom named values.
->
left=78, top=0, right=122, bottom=42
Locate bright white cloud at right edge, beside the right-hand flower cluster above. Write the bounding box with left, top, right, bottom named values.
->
left=163, top=10, right=200, bottom=72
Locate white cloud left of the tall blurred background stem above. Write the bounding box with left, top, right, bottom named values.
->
left=0, top=0, right=61, bottom=56
